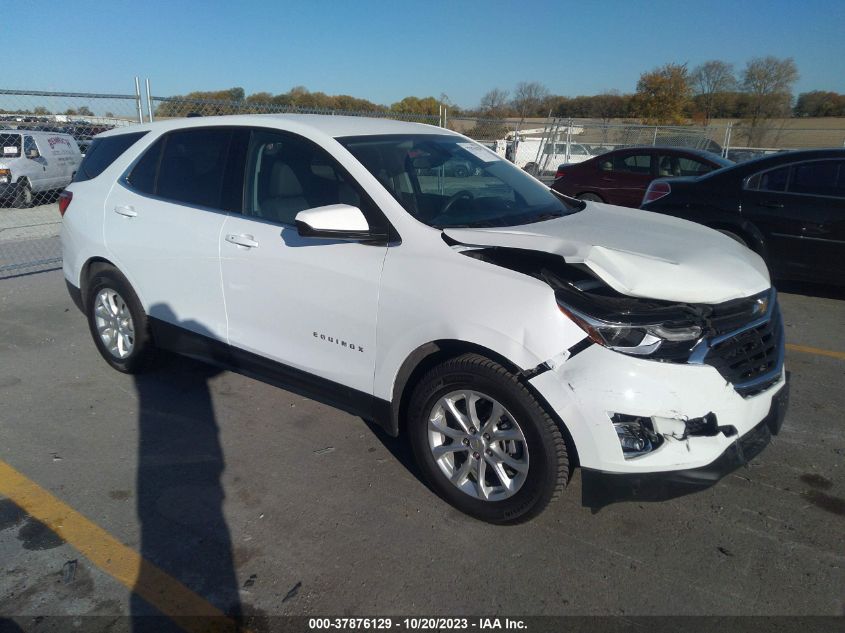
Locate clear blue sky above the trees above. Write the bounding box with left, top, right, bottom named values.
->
left=0, top=0, right=845, bottom=107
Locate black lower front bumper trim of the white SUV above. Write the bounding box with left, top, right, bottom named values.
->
left=581, top=383, right=789, bottom=512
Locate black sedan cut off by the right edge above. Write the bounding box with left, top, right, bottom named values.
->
left=642, top=149, right=845, bottom=284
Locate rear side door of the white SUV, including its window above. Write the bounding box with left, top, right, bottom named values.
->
left=104, top=127, right=241, bottom=341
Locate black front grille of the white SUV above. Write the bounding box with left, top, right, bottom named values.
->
left=704, top=304, right=783, bottom=397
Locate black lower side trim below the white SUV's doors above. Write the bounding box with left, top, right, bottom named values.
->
left=150, top=317, right=390, bottom=431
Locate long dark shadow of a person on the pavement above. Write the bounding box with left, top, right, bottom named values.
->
left=131, top=308, right=242, bottom=633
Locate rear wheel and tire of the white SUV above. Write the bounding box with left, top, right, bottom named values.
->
left=85, top=268, right=155, bottom=374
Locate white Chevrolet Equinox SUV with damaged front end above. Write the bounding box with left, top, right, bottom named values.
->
left=60, top=115, right=787, bottom=523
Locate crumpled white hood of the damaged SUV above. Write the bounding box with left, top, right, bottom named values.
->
left=443, top=202, right=771, bottom=303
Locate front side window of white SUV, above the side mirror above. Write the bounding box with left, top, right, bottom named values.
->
left=244, top=130, right=364, bottom=225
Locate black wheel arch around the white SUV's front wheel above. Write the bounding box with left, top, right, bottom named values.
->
left=390, top=339, right=579, bottom=475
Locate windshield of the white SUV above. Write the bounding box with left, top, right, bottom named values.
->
left=338, top=134, right=583, bottom=228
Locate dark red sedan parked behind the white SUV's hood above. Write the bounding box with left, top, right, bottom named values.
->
left=552, top=146, right=734, bottom=207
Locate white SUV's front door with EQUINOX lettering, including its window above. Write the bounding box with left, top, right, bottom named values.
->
left=220, top=129, right=387, bottom=399
